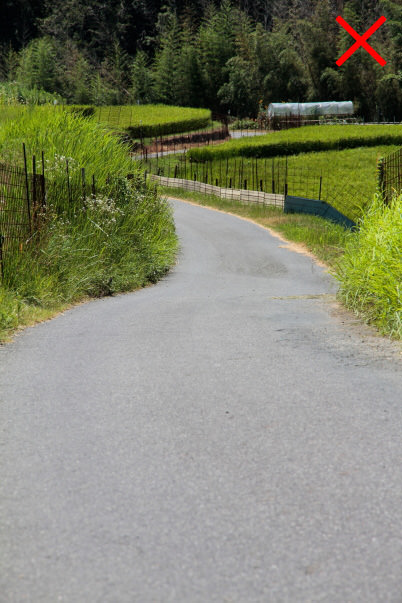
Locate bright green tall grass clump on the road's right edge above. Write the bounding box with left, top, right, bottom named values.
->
left=335, top=195, right=402, bottom=339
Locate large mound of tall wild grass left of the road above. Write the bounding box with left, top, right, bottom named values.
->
left=0, top=107, right=177, bottom=338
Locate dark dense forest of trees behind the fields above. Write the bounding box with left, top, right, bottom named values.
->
left=0, top=0, right=402, bottom=121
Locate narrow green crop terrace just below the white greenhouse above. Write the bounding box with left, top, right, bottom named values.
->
left=187, top=125, right=402, bottom=161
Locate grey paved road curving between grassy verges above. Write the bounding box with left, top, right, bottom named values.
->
left=0, top=202, right=402, bottom=603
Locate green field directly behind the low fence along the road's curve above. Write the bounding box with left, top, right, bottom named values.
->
left=145, top=145, right=397, bottom=220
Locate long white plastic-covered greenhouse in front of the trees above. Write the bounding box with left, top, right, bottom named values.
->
left=268, top=101, right=354, bottom=130
